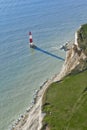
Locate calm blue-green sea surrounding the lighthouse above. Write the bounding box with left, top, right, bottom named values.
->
left=0, top=0, right=87, bottom=130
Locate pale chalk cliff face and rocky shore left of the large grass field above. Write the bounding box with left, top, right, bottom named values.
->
left=11, top=75, right=61, bottom=130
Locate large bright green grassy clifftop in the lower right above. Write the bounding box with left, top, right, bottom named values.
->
left=42, top=70, right=87, bottom=130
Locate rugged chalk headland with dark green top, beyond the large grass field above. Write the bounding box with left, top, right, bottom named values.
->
left=55, top=24, right=87, bottom=81
